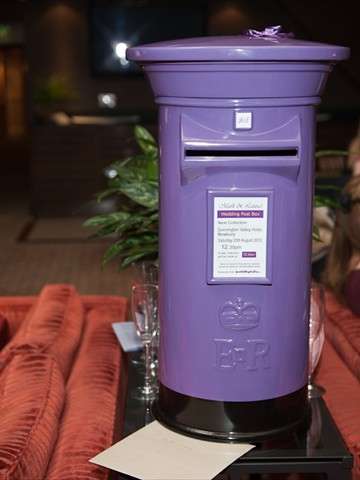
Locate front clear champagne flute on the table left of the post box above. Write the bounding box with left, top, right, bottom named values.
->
left=131, top=284, right=158, bottom=400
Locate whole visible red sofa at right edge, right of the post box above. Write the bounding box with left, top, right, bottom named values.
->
left=316, top=292, right=360, bottom=480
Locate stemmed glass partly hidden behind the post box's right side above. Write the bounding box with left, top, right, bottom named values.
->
left=308, top=283, right=325, bottom=398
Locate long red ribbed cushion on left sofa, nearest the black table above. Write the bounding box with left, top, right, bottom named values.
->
left=46, top=304, right=126, bottom=480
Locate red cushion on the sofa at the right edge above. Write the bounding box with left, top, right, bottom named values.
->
left=325, top=292, right=360, bottom=380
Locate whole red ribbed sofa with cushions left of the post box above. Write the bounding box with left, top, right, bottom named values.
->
left=0, top=285, right=127, bottom=480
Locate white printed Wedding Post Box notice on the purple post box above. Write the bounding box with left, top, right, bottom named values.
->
left=213, top=197, right=268, bottom=279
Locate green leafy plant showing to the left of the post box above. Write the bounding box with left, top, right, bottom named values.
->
left=84, top=126, right=159, bottom=268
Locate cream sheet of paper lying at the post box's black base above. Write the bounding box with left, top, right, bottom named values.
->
left=90, top=421, right=254, bottom=480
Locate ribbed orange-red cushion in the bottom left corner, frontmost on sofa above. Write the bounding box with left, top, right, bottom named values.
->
left=0, top=353, right=64, bottom=480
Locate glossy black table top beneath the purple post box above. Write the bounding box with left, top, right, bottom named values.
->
left=111, top=353, right=352, bottom=480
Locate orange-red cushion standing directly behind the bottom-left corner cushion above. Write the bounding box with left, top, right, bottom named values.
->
left=1, top=285, right=84, bottom=378
